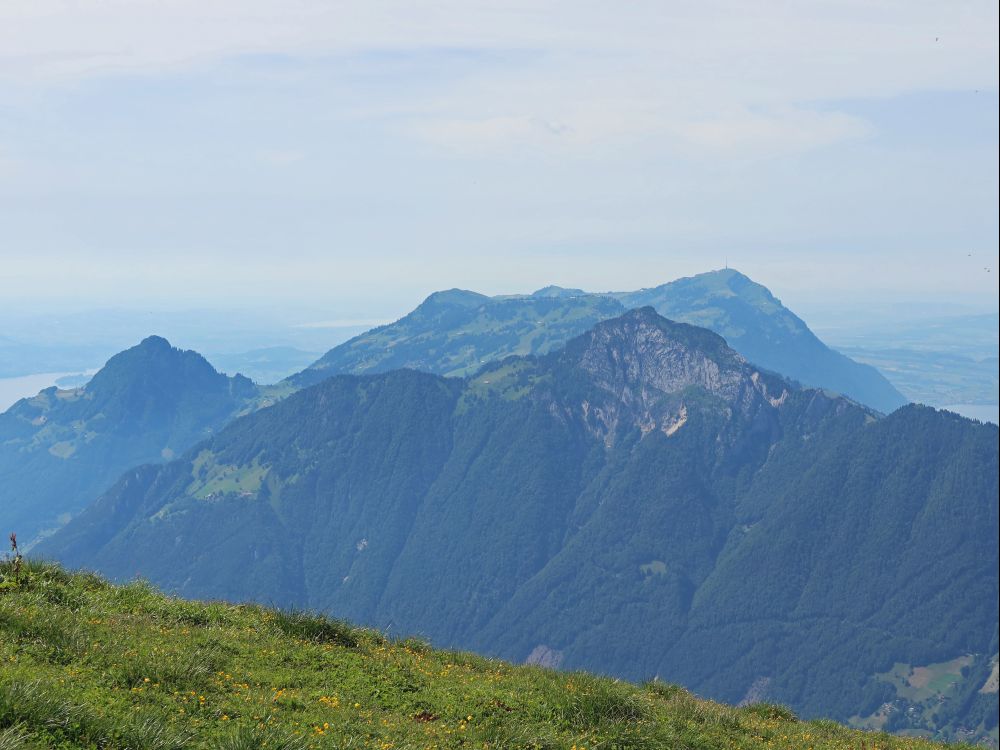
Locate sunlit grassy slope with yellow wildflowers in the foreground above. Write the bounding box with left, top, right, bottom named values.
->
left=0, top=560, right=968, bottom=750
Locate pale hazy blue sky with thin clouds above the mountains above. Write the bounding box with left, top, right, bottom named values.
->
left=0, top=0, right=998, bottom=318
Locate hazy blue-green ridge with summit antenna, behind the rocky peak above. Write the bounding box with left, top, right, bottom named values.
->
left=288, top=269, right=906, bottom=413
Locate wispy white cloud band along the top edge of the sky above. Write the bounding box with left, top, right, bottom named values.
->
left=0, top=0, right=997, bottom=96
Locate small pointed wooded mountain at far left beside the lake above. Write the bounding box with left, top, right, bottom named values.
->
left=0, top=336, right=261, bottom=543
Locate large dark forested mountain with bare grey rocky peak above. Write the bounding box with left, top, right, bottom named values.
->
left=36, top=310, right=998, bottom=747
